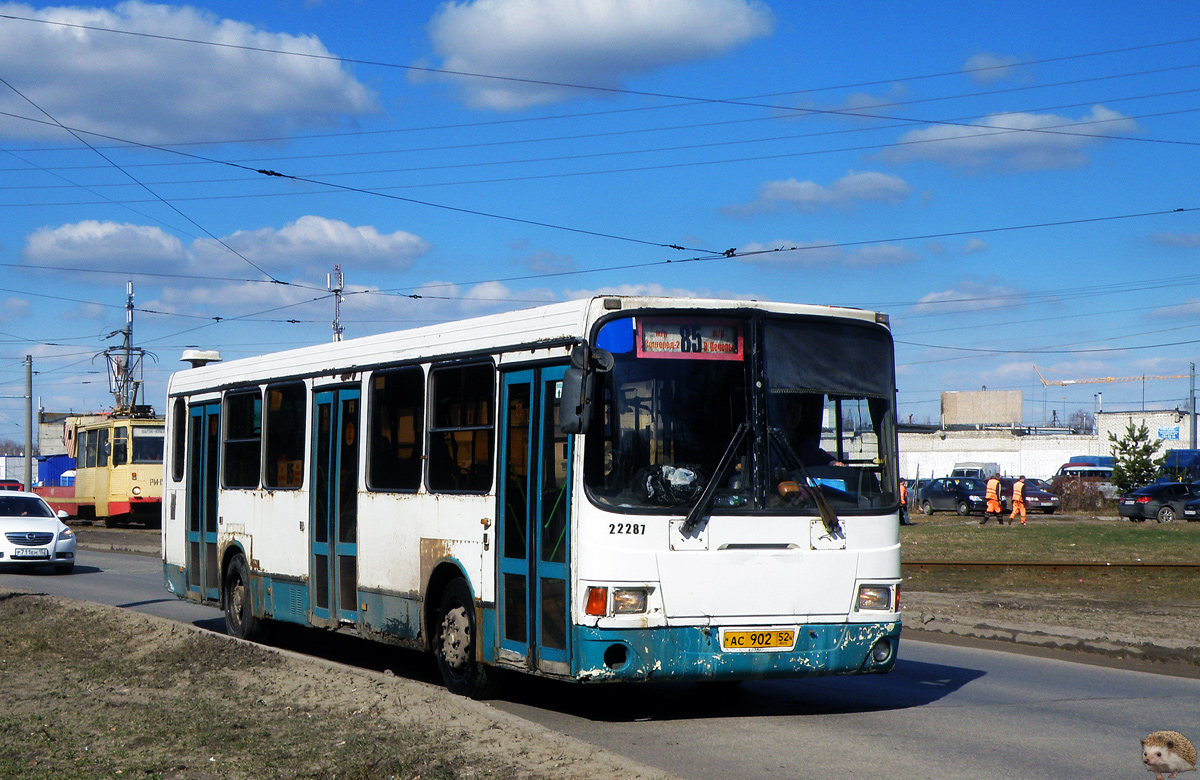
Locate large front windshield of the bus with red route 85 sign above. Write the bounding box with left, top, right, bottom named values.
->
left=584, top=313, right=896, bottom=515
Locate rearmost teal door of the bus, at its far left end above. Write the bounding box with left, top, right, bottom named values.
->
left=187, top=402, right=221, bottom=600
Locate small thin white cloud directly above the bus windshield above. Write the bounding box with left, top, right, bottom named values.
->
left=726, top=170, right=912, bottom=215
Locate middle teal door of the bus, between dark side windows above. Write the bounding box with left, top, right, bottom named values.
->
left=310, top=388, right=360, bottom=625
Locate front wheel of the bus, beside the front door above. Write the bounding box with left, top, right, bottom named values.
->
left=433, top=577, right=500, bottom=698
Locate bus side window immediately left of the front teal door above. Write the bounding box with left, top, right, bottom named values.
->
left=428, top=364, right=496, bottom=493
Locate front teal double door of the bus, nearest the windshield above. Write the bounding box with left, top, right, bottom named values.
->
left=497, top=366, right=572, bottom=674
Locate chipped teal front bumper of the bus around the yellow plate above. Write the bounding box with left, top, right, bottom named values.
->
left=572, top=620, right=900, bottom=682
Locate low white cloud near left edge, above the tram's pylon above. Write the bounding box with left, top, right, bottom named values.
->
left=22, top=220, right=186, bottom=271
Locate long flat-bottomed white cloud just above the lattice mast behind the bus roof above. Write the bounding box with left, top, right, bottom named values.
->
left=192, top=215, right=430, bottom=275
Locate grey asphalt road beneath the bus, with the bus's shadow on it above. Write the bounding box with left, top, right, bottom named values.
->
left=0, top=551, right=1200, bottom=780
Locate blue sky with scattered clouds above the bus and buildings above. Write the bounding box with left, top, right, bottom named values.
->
left=0, top=0, right=1200, bottom=440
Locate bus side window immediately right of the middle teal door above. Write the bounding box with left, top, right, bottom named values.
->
left=367, top=366, right=425, bottom=491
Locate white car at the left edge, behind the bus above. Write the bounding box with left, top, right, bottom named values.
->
left=0, top=492, right=76, bottom=574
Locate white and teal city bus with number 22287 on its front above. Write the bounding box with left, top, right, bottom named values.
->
left=162, top=296, right=900, bottom=696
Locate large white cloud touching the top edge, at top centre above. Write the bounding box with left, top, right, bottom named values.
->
left=428, top=0, right=774, bottom=110
